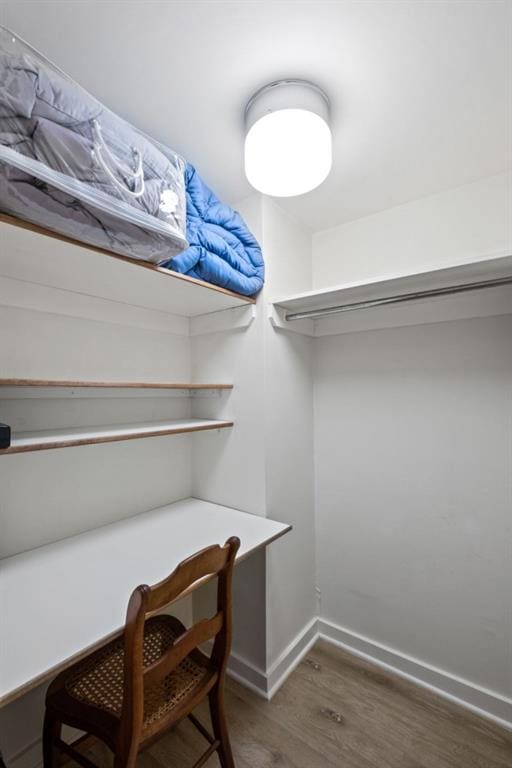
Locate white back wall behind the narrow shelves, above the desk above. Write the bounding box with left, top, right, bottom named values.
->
left=0, top=296, right=192, bottom=557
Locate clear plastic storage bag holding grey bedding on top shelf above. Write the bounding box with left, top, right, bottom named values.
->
left=0, top=26, right=187, bottom=263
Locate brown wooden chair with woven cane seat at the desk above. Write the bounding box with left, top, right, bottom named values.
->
left=43, top=538, right=240, bottom=768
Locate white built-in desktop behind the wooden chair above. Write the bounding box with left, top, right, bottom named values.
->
left=0, top=499, right=290, bottom=705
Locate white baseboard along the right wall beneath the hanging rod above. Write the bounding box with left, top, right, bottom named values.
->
left=318, top=619, right=512, bottom=729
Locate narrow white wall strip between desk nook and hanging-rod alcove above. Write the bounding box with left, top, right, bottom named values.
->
left=263, top=199, right=316, bottom=669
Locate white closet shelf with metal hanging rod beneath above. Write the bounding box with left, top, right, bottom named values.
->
left=271, top=254, right=512, bottom=336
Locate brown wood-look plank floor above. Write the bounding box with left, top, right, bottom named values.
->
left=85, top=641, right=512, bottom=768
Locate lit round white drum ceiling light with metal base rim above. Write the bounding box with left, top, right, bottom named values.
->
left=245, top=80, right=332, bottom=197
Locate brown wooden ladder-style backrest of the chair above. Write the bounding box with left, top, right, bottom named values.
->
left=120, top=537, right=240, bottom=763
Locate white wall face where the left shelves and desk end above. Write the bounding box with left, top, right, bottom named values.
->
left=191, top=195, right=266, bottom=677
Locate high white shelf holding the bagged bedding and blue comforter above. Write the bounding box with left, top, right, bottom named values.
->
left=0, top=214, right=255, bottom=317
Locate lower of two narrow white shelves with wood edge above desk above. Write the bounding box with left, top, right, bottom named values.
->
left=0, top=419, right=233, bottom=455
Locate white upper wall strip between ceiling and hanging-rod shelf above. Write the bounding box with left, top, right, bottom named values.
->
left=313, top=172, right=512, bottom=288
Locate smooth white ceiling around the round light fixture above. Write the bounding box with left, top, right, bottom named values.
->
left=0, top=0, right=512, bottom=230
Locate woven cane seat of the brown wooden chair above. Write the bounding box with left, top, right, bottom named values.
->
left=64, top=615, right=212, bottom=729
